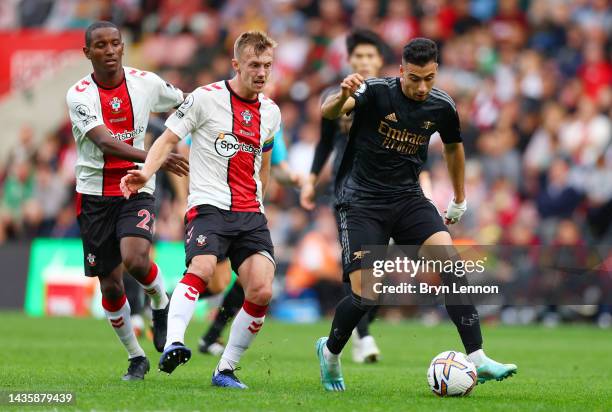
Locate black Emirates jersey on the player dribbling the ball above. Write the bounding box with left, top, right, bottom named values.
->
left=336, top=77, right=462, bottom=204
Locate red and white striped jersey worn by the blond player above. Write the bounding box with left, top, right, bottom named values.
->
left=166, top=81, right=281, bottom=213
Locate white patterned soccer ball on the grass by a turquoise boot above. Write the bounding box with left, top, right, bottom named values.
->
left=427, top=350, right=477, bottom=396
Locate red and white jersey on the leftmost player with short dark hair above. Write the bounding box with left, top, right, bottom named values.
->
left=66, top=67, right=183, bottom=196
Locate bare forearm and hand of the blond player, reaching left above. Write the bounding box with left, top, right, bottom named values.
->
left=120, top=129, right=184, bottom=198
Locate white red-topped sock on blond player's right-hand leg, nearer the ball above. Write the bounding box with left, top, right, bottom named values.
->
left=215, top=300, right=268, bottom=374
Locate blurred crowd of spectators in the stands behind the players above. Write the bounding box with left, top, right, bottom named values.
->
left=0, top=0, right=612, bottom=326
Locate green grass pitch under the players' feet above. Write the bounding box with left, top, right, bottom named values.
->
left=0, top=313, right=612, bottom=412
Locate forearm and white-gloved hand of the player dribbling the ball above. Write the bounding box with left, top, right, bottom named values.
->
left=444, top=143, right=467, bottom=224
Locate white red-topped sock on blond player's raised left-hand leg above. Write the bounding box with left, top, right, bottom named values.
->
left=164, top=273, right=206, bottom=349
